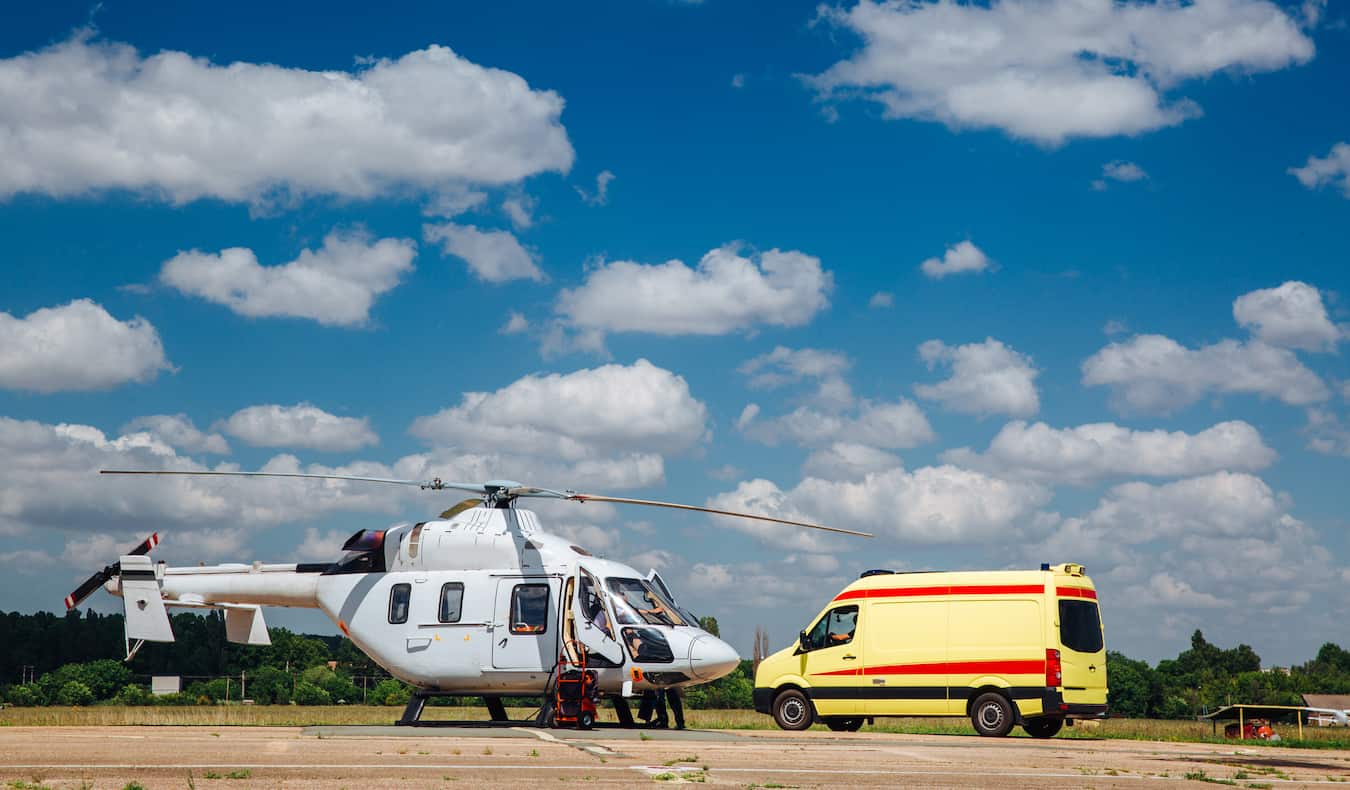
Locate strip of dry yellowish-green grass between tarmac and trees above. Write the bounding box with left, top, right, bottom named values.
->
left=0, top=705, right=1350, bottom=749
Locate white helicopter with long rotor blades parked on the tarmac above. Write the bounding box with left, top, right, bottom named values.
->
left=65, top=470, right=871, bottom=725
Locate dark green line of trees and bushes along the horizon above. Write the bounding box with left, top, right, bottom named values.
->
left=0, top=610, right=1350, bottom=718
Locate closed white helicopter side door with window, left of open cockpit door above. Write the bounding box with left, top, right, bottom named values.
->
left=493, top=577, right=559, bottom=671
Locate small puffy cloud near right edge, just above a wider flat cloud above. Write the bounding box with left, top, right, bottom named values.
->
left=1233, top=280, right=1345, bottom=351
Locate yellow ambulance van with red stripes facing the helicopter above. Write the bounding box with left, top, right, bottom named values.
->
left=755, top=563, right=1106, bottom=737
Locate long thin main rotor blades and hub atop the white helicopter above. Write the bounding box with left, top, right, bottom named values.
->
left=99, top=469, right=875, bottom=534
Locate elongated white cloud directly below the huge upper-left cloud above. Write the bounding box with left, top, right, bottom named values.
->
left=159, top=231, right=416, bottom=327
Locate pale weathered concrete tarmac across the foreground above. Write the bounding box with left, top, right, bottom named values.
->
left=0, top=727, right=1350, bottom=790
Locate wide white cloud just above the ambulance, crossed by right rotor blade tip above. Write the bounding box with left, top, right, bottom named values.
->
left=707, top=465, right=1050, bottom=551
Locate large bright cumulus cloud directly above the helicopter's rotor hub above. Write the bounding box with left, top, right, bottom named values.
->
left=410, top=359, right=707, bottom=488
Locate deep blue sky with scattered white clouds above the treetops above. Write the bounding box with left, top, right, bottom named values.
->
left=0, top=0, right=1350, bottom=663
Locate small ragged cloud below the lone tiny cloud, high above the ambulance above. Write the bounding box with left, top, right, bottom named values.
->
left=914, top=338, right=1041, bottom=417
